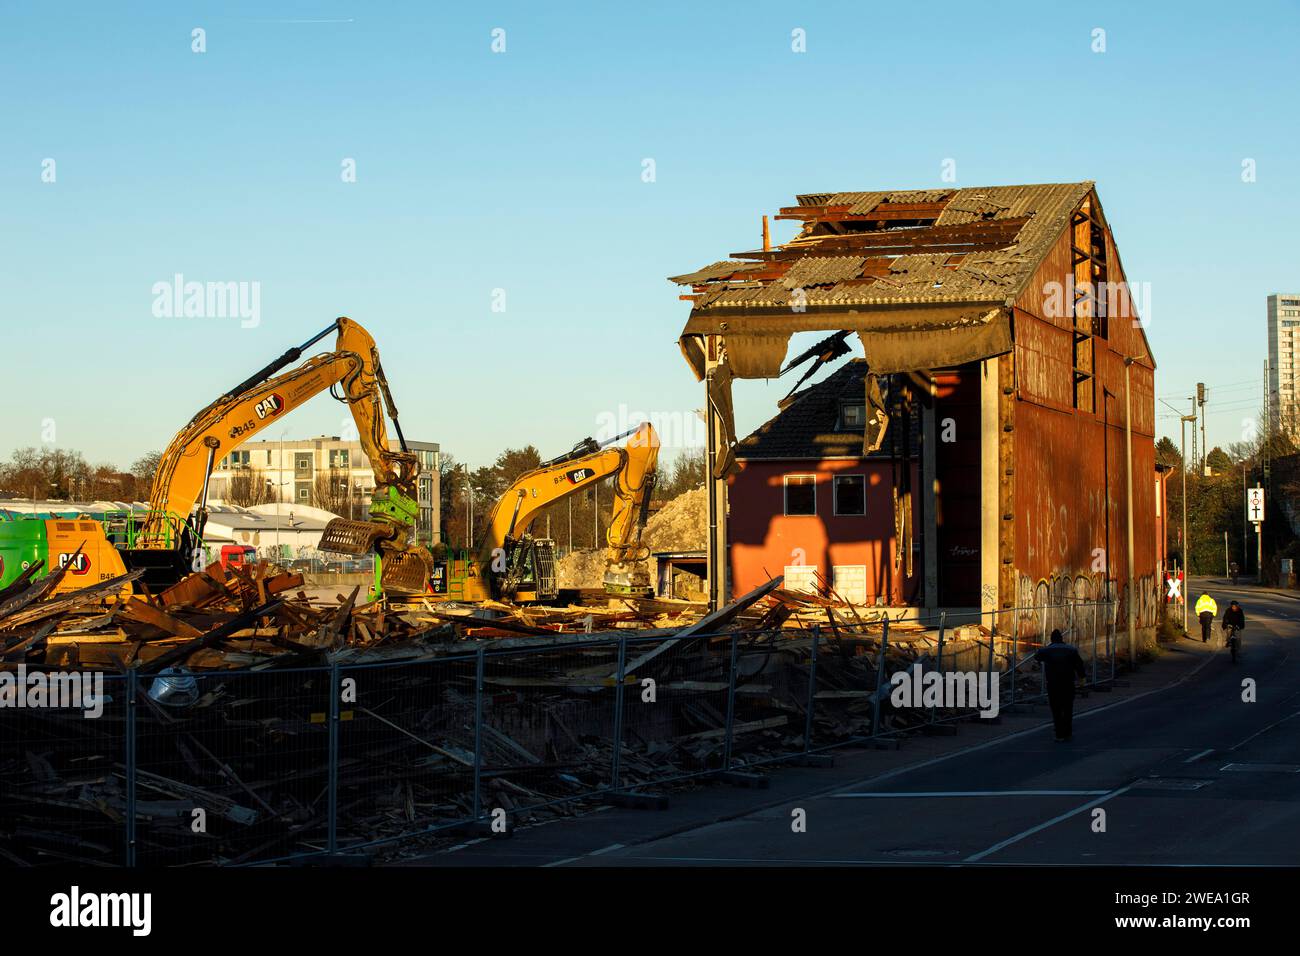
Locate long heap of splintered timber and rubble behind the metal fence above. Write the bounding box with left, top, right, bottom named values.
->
left=0, top=567, right=1003, bottom=864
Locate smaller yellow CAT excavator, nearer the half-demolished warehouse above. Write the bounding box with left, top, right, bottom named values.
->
left=433, top=423, right=659, bottom=604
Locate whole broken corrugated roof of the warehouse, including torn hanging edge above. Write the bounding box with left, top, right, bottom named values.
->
left=671, top=182, right=1093, bottom=378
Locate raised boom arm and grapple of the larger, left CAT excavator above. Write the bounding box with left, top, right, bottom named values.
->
left=121, top=317, right=433, bottom=593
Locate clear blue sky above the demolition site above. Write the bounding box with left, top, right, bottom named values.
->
left=0, top=0, right=1300, bottom=466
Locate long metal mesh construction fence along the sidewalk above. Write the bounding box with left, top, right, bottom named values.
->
left=0, top=602, right=1123, bottom=866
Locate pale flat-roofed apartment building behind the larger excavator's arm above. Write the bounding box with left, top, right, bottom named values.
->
left=208, top=434, right=442, bottom=545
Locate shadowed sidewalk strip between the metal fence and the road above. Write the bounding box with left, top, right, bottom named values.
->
left=413, top=639, right=1216, bottom=866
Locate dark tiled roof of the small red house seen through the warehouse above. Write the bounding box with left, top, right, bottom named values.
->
left=736, top=359, right=917, bottom=460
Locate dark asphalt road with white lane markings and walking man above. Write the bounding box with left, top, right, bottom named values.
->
left=424, top=580, right=1300, bottom=866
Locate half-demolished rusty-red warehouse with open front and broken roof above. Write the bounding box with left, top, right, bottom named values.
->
left=673, top=182, right=1164, bottom=650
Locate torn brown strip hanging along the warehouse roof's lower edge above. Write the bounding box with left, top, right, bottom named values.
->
left=679, top=302, right=1011, bottom=380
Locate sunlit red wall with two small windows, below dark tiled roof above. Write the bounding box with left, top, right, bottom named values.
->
left=728, top=459, right=922, bottom=605
